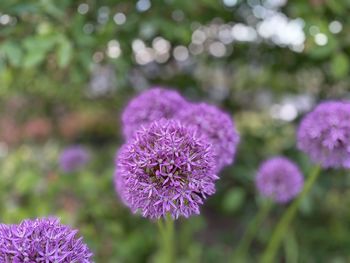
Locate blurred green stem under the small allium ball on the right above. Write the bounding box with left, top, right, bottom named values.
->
left=231, top=200, right=272, bottom=263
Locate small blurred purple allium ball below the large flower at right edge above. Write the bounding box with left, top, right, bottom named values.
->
left=255, top=157, right=304, bottom=204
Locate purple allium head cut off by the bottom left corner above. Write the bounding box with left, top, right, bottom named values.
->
left=0, top=218, right=92, bottom=263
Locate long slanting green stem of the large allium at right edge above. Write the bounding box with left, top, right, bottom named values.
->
left=261, top=166, right=321, bottom=263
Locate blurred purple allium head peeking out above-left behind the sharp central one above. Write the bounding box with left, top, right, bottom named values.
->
left=122, top=87, right=187, bottom=139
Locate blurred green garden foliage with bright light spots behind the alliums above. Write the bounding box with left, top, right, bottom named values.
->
left=0, top=0, right=350, bottom=263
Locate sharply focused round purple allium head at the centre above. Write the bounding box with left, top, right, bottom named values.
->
left=115, top=119, right=218, bottom=219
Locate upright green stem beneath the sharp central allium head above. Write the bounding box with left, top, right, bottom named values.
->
left=157, top=214, right=175, bottom=263
